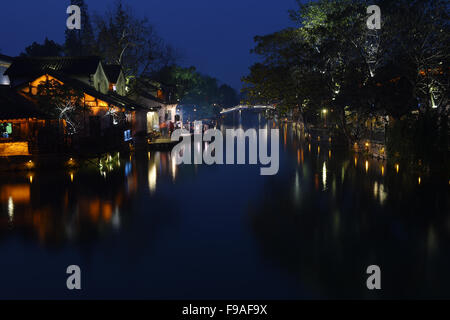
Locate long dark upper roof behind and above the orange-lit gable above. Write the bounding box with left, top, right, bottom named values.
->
left=5, top=56, right=101, bottom=77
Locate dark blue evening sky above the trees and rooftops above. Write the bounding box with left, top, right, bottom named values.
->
left=0, top=0, right=296, bottom=89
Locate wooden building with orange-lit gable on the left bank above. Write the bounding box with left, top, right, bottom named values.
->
left=0, top=57, right=159, bottom=155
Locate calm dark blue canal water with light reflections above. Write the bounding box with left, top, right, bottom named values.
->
left=0, top=110, right=450, bottom=299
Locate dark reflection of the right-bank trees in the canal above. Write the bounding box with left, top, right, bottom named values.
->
left=249, top=144, right=450, bottom=298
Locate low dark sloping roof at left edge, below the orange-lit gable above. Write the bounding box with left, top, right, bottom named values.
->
left=0, top=86, right=47, bottom=120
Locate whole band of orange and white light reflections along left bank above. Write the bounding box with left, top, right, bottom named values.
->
left=0, top=148, right=186, bottom=245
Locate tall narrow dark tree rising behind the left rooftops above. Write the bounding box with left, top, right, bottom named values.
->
left=64, top=0, right=95, bottom=56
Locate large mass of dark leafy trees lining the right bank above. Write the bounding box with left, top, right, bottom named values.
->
left=243, top=0, right=450, bottom=165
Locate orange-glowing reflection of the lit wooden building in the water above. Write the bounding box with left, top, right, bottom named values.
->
left=0, top=166, right=128, bottom=243
